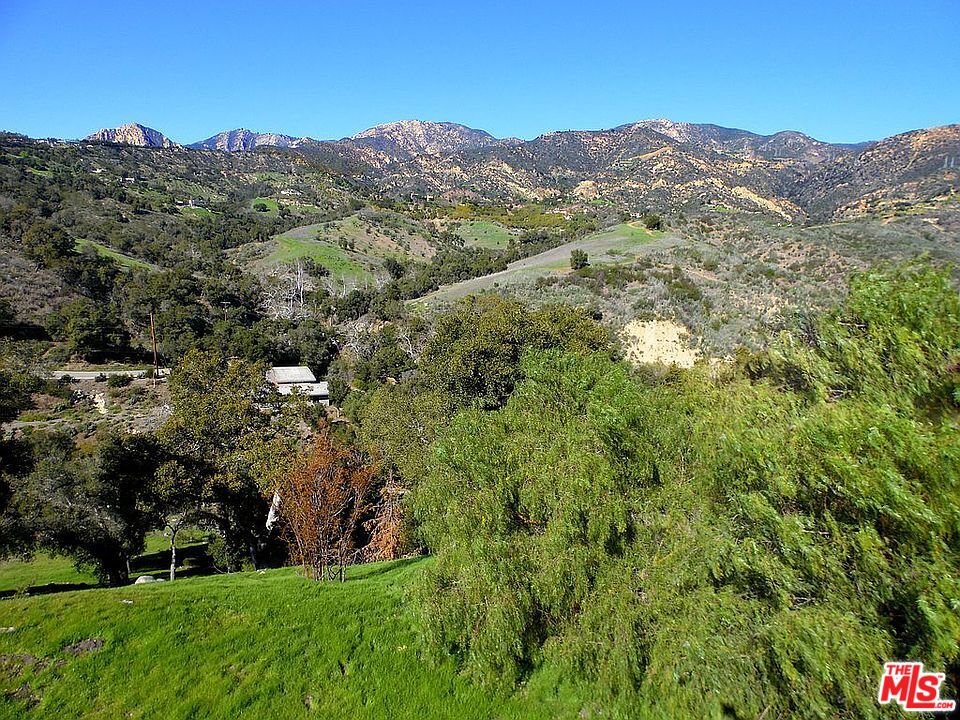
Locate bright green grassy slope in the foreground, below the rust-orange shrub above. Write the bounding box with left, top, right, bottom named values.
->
left=0, top=560, right=582, bottom=720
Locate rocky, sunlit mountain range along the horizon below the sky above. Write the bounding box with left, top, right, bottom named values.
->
left=86, top=119, right=960, bottom=221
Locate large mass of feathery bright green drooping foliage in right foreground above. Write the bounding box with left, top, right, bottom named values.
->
left=413, top=267, right=960, bottom=718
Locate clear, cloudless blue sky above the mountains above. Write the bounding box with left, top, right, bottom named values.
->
left=0, top=0, right=960, bottom=143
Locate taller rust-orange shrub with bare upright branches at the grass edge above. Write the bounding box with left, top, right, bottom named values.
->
left=278, top=429, right=378, bottom=582
